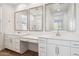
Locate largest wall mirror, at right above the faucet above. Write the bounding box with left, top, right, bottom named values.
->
left=45, top=3, right=75, bottom=31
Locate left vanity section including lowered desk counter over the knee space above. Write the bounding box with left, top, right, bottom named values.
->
left=4, top=34, right=38, bottom=54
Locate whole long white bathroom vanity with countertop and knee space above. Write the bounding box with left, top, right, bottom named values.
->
left=5, top=32, right=79, bottom=56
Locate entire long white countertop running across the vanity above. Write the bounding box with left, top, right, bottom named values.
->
left=4, top=32, right=79, bottom=41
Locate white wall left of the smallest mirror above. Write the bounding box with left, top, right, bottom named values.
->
left=2, top=5, right=14, bottom=33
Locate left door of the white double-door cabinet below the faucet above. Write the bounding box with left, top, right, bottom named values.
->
left=47, top=44, right=57, bottom=56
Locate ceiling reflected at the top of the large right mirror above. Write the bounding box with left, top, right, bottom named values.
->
left=47, top=3, right=71, bottom=13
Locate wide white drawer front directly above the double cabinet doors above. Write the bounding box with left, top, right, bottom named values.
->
left=47, top=39, right=70, bottom=46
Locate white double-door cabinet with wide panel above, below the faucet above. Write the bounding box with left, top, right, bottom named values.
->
left=47, top=39, right=70, bottom=56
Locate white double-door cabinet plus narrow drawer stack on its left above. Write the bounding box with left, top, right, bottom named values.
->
left=39, top=38, right=71, bottom=56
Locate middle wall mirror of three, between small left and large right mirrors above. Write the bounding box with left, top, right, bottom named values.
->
left=29, top=6, right=43, bottom=31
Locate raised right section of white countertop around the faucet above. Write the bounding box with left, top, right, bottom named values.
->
left=40, top=33, right=79, bottom=41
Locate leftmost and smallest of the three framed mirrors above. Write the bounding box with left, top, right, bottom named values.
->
left=14, top=10, right=28, bottom=31
